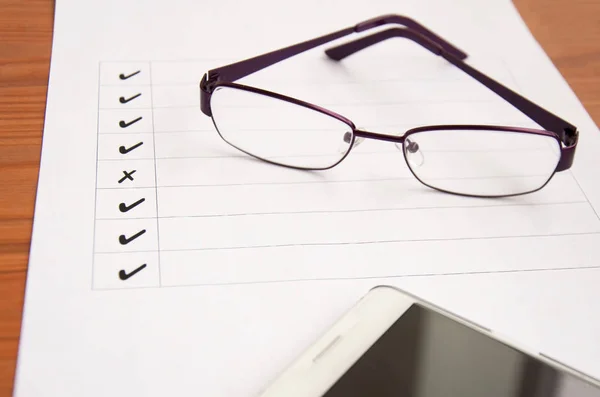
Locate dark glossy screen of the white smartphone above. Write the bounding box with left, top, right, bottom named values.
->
left=325, top=304, right=600, bottom=397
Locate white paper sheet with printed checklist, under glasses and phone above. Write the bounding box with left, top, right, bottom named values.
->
left=15, top=0, right=600, bottom=397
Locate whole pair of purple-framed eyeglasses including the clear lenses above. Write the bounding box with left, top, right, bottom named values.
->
left=200, top=15, right=578, bottom=197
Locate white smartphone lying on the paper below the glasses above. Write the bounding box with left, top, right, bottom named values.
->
left=260, top=286, right=600, bottom=397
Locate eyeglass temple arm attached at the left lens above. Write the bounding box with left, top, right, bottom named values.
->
left=207, top=15, right=467, bottom=82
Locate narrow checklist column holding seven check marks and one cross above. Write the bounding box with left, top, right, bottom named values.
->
left=93, top=63, right=160, bottom=288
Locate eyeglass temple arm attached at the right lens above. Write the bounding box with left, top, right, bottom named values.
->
left=325, top=28, right=577, bottom=171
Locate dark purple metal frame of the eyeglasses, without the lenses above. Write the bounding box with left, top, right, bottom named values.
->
left=200, top=15, right=579, bottom=197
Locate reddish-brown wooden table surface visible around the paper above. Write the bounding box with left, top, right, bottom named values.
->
left=0, top=0, right=600, bottom=396
